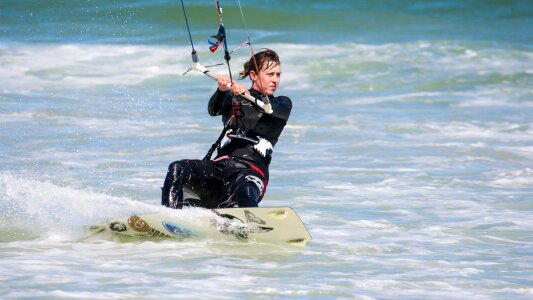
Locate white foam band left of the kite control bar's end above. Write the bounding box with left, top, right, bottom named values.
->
left=0, top=44, right=186, bottom=93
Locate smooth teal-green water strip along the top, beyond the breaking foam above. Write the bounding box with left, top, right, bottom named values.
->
left=0, top=0, right=533, bottom=45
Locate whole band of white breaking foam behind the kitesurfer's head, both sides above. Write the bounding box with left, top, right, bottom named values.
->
left=0, top=42, right=533, bottom=96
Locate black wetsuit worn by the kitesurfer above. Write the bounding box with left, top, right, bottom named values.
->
left=161, top=89, right=292, bottom=208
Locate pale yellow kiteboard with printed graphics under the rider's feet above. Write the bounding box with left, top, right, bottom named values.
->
left=89, top=207, right=311, bottom=246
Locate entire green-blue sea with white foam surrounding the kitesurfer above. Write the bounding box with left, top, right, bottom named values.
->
left=0, top=0, right=533, bottom=299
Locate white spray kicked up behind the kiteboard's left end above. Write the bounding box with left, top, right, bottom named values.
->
left=0, top=173, right=158, bottom=240
